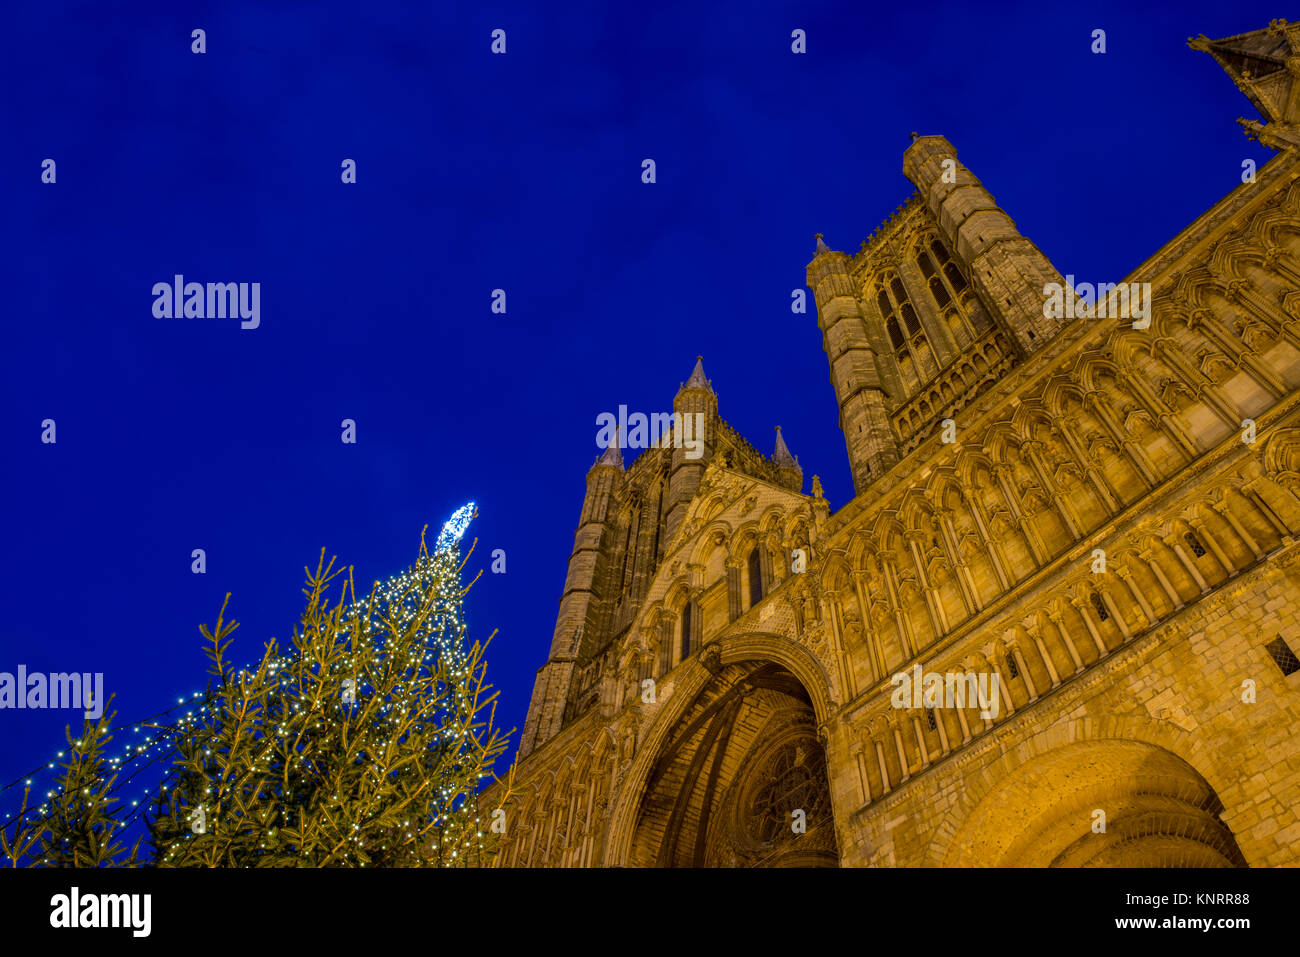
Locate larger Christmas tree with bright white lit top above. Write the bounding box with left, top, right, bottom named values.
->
left=151, top=505, right=506, bottom=867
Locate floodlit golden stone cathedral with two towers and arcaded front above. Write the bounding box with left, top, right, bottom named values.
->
left=484, top=21, right=1300, bottom=867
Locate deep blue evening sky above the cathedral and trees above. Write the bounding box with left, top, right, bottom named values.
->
left=0, top=0, right=1287, bottom=805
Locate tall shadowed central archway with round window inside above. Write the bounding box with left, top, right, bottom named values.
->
left=628, top=661, right=839, bottom=867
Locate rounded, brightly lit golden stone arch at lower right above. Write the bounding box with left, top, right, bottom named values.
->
left=944, top=739, right=1245, bottom=867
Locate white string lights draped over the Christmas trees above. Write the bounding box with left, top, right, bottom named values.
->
left=0, top=502, right=503, bottom=866
